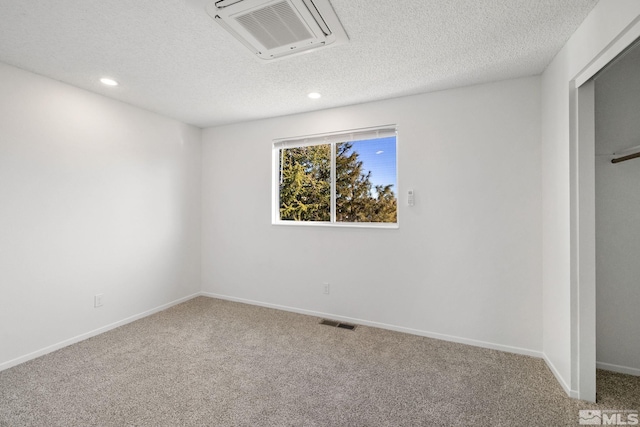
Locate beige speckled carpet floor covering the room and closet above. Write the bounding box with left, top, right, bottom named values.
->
left=0, top=297, right=640, bottom=427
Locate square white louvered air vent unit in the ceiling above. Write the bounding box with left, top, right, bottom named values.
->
left=207, top=0, right=349, bottom=60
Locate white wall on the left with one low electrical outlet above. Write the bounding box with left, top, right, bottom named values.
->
left=0, top=64, right=201, bottom=369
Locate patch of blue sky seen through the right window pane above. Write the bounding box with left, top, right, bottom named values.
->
left=344, top=136, right=398, bottom=197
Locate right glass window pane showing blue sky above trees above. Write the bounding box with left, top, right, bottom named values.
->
left=336, top=137, right=397, bottom=223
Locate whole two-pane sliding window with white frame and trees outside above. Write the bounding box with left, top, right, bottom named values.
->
left=273, top=126, right=398, bottom=227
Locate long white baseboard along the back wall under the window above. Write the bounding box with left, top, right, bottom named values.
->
left=200, top=292, right=542, bottom=358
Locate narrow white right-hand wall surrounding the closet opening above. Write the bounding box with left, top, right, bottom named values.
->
left=542, top=0, right=640, bottom=397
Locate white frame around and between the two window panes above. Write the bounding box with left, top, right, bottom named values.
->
left=271, top=125, right=400, bottom=229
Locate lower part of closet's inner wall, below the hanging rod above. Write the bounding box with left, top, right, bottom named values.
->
left=596, top=156, right=640, bottom=375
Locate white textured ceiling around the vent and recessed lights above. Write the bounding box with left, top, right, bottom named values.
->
left=0, top=0, right=597, bottom=127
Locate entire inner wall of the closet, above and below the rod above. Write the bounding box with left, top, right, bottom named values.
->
left=595, top=47, right=640, bottom=375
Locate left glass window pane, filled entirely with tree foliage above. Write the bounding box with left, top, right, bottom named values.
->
left=279, top=144, right=331, bottom=221
